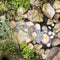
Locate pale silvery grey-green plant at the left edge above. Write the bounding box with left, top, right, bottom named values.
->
left=0, top=16, right=12, bottom=38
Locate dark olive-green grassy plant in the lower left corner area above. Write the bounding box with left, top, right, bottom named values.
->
left=0, top=39, right=16, bottom=55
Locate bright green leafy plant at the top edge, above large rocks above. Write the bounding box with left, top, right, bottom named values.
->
left=10, top=0, right=30, bottom=10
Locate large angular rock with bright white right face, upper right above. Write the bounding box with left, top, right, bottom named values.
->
left=42, top=3, right=55, bottom=19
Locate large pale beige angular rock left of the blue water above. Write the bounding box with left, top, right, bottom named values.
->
left=17, top=30, right=31, bottom=43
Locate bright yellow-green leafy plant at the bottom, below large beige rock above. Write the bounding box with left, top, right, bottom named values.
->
left=20, top=42, right=37, bottom=60
